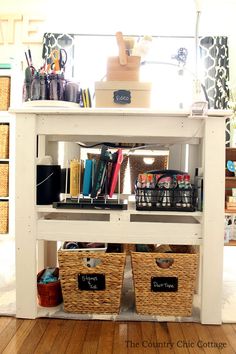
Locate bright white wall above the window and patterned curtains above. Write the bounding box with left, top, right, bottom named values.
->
left=0, top=0, right=236, bottom=82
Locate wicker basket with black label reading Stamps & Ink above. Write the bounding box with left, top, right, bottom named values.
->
left=58, top=250, right=125, bottom=314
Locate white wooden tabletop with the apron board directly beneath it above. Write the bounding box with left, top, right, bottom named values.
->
left=10, top=106, right=231, bottom=144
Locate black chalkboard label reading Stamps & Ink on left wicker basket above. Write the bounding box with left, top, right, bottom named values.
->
left=78, top=273, right=106, bottom=291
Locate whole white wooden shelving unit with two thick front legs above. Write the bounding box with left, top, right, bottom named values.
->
left=11, top=107, right=228, bottom=324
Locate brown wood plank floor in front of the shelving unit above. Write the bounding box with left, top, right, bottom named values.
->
left=0, top=317, right=236, bottom=354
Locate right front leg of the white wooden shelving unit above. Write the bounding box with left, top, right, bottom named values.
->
left=201, top=117, right=225, bottom=324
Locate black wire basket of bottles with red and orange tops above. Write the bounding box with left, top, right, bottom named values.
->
left=135, top=170, right=196, bottom=211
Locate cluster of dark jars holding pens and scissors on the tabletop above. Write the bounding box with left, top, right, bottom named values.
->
left=23, top=49, right=91, bottom=107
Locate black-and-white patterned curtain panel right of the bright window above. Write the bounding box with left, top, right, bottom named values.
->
left=200, top=37, right=230, bottom=146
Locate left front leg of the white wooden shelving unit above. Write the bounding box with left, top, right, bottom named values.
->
left=15, top=114, right=37, bottom=319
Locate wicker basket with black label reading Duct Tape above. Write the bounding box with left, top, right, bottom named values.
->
left=131, top=248, right=198, bottom=317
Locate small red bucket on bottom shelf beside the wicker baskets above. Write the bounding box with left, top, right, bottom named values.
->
left=37, top=268, right=63, bottom=307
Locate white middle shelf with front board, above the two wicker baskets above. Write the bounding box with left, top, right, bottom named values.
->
left=37, top=202, right=202, bottom=245
